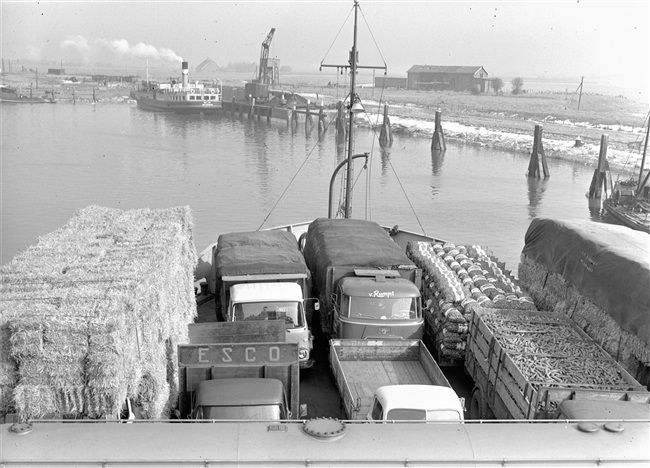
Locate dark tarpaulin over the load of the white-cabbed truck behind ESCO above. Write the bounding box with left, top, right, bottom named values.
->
left=213, top=231, right=309, bottom=278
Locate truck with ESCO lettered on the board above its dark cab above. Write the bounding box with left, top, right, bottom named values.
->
left=178, top=321, right=306, bottom=420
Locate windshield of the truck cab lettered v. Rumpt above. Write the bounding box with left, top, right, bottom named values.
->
left=342, top=296, right=420, bottom=320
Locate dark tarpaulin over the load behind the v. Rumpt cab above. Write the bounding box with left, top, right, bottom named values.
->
left=303, top=218, right=415, bottom=292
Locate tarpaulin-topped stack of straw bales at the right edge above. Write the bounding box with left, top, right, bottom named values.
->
left=519, top=218, right=650, bottom=388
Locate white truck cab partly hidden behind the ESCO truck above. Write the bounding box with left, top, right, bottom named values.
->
left=226, top=283, right=314, bottom=369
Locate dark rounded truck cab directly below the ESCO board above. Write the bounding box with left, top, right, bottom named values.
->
left=192, top=378, right=291, bottom=421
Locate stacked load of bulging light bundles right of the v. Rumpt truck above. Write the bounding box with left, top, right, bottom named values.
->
left=406, top=242, right=535, bottom=365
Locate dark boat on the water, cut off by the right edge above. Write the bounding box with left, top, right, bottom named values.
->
left=603, top=114, right=650, bottom=234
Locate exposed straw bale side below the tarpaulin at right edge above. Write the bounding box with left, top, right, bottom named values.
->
left=519, top=255, right=650, bottom=388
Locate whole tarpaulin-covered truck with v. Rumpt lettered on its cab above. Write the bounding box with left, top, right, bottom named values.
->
left=300, top=218, right=424, bottom=339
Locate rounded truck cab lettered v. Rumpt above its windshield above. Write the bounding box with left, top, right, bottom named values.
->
left=332, top=270, right=424, bottom=340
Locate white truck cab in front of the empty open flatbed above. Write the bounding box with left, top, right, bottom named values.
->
left=368, top=385, right=464, bottom=421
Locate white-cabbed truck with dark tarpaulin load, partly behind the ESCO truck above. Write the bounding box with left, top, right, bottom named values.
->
left=210, top=231, right=314, bottom=368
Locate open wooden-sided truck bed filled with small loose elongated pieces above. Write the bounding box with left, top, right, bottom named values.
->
left=465, top=308, right=650, bottom=419
